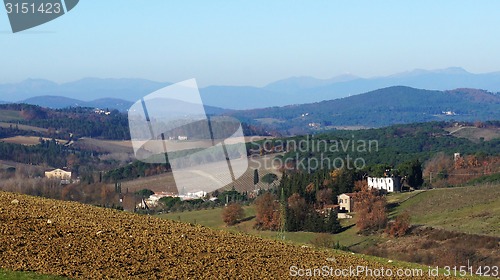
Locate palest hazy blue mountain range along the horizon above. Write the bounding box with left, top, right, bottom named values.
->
left=0, top=67, right=500, bottom=110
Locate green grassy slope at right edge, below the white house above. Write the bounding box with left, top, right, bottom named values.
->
left=391, top=184, right=500, bottom=236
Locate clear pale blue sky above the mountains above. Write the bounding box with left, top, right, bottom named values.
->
left=0, top=0, right=500, bottom=86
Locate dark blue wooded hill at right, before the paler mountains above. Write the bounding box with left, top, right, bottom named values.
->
left=230, top=86, right=500, bottom=134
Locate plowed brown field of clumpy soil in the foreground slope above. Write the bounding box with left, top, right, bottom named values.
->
left=0, top=192, right=454, bottom=279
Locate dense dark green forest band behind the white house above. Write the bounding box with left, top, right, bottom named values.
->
left=254, top=122, right=500, bottom=171
